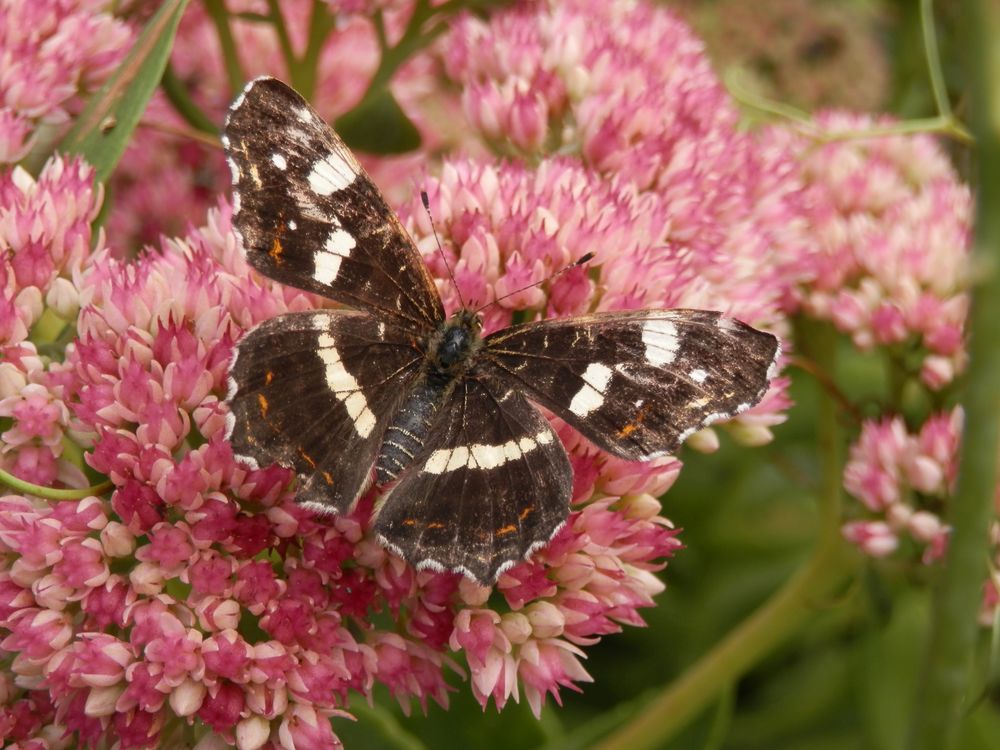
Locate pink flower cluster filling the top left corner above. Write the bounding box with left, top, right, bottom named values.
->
left=0, top=0, right=132, bottom=164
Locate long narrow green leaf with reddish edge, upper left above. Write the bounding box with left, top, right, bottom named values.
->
left=57, top=0, right=188, bottom=182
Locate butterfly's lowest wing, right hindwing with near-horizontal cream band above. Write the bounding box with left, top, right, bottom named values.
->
left=374, top=378, right=573, bottom=585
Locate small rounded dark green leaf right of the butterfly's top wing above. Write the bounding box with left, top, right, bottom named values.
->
left=334, top=88, right=420, bottom=154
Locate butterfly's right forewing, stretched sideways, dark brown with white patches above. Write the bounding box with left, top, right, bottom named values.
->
left=483, top=310, right=779, bottom=460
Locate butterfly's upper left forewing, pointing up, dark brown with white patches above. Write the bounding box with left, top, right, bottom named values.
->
left=229, top=78, right=444, bottom=330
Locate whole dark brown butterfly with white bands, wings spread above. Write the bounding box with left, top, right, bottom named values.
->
left=222, top=78, right=779, bottom=585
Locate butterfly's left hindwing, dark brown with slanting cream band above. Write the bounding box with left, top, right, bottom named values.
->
left=227, top=310, right=422, bottom=512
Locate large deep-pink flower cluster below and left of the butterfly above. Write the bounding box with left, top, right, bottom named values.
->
left=0, top=181, right=679, bottom=747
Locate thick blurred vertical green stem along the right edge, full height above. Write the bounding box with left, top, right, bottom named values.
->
left=910, top=0, right=1000, bottom=750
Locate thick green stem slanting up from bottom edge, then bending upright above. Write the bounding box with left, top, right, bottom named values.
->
left=596, top=325, right=858, bottom=750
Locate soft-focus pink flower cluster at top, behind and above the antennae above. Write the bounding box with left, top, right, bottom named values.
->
left=441, top=0, right=799, bottom=302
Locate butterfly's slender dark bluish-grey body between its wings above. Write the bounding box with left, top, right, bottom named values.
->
left=375, top=309, right=483, bottom=484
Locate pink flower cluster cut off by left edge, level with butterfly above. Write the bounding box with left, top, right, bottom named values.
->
left=0, top=158, right=103, bottom=484
